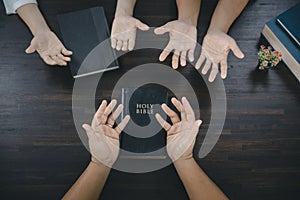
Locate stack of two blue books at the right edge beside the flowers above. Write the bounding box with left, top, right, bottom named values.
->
left=262, top=3, right=300, bottom=81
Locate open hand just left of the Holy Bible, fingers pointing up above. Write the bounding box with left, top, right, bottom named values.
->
left=82, top=100, right=130, bottom=167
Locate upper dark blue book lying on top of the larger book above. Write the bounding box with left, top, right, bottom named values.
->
left=277, top=3, right=300, bottom=47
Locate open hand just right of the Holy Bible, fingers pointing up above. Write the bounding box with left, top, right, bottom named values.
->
left=155, top=97, right=202, bottom=162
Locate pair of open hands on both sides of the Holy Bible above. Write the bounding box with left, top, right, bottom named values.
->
left=83, top=97, right=202, bottom=167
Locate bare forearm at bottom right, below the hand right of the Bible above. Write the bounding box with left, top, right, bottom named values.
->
left=174, top=158, right=228, bottom=200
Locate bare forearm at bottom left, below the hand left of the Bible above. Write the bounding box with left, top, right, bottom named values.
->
left=63, top=162, right=110, bottom=200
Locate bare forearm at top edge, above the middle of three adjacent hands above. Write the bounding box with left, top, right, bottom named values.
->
left=176, top=0, right=201, bottom=26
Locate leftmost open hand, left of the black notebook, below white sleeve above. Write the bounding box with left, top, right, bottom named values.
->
left=25, top=30, right=72, bottom=66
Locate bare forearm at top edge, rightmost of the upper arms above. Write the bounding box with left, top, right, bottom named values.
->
left=209, top=0, right=249, bottom=33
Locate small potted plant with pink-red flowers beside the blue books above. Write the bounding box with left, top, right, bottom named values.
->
left=257, top=45, right=282, bottom=70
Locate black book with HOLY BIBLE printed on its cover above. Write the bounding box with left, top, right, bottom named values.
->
left=120, top=86, right=169, bottom=159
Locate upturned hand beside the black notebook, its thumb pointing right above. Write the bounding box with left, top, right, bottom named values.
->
left=111, top=16, right=149, bottom=51
